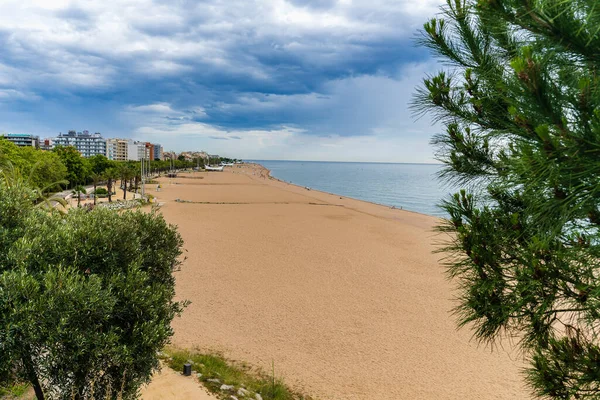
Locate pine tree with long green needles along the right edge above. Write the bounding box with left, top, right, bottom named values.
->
left=413, top=0, right=600, bottom=399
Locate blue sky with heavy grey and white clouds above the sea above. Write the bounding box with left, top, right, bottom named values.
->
left=0, top=0, right=442, bottom=162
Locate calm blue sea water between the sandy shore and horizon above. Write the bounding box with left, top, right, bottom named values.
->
left=252, top=160, right=452, bottom=217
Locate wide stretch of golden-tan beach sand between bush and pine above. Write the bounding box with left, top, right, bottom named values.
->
left=148, top=166, right=528, bottom=399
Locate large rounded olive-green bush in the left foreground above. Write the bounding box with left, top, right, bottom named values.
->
left=0, top=170, right=183, bottom=399
